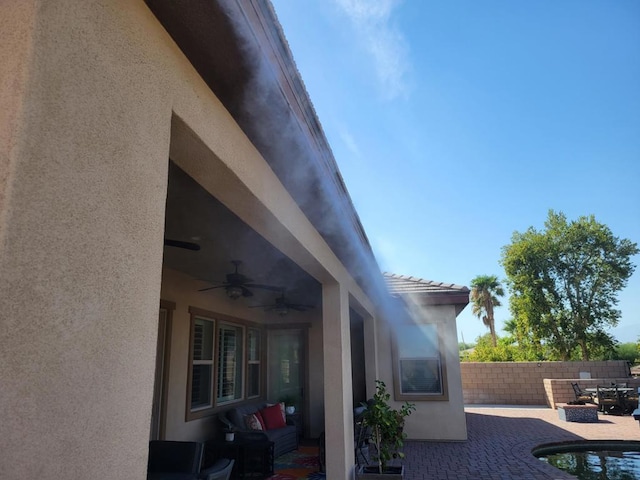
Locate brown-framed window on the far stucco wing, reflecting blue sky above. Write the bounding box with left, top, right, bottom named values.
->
left=394, top=324, right=448, bottom=400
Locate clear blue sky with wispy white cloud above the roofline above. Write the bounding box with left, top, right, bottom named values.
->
left=273, top=0, right=640, bottom=342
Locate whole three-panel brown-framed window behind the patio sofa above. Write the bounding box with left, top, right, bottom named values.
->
left=186, top=307, right=263, bottom=421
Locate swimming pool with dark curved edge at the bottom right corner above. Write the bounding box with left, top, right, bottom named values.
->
left=531, top=440, right=640, bottom=480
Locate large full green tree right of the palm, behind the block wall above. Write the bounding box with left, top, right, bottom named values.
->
left=501, top=210, right=640, bottom=360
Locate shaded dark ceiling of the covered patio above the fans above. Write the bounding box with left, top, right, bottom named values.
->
left=164, top=162, right=322, bottom=308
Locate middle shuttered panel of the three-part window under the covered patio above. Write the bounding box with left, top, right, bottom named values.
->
left=217, top=325, right=243, bottom=403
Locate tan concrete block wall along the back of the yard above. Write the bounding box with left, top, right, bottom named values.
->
left=460, top=360, right=640, bottom=408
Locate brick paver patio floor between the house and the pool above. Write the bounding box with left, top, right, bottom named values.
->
left=404, top=406, right=640, bottom=480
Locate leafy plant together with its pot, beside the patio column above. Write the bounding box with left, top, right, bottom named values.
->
left=358, top=380, right=416, bottom=480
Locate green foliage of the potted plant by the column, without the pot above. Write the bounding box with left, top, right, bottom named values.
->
left=362, top=380, right=416, bottom=473
